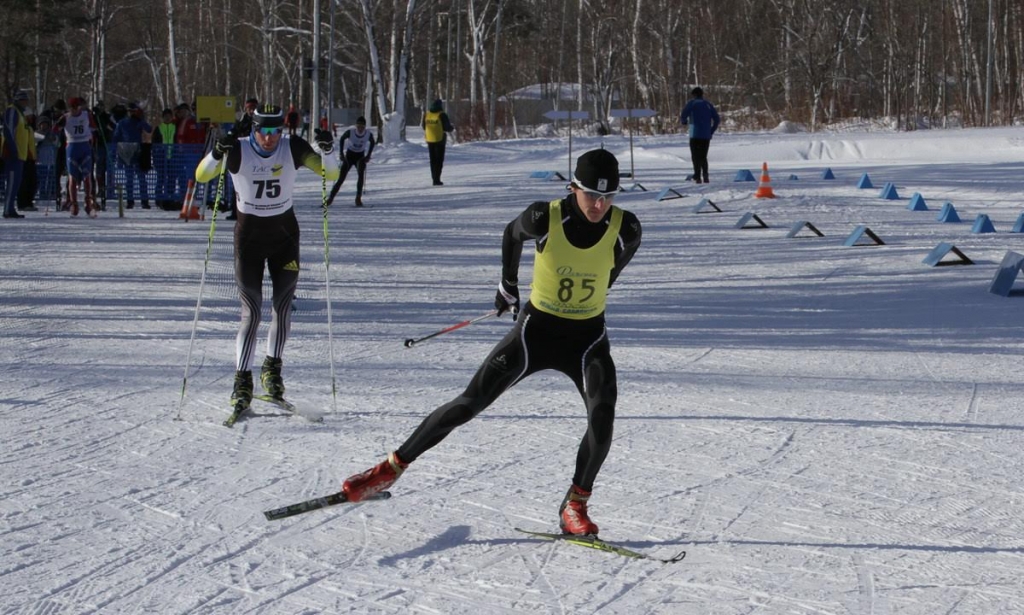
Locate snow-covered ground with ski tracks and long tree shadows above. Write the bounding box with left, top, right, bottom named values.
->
left=0, top=129, right=1024, bottom=615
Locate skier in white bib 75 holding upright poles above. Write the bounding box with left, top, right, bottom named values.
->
left=196, top=104, right=338, bottom=414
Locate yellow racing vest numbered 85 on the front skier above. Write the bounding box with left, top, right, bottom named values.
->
left=529, top=201, right=623, bottom=320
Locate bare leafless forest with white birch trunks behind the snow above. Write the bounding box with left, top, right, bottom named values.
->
left=0, top=0, right=1024, bottom=139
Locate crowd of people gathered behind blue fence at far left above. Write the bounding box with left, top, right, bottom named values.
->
left=0, top=90, right=208, bottom=218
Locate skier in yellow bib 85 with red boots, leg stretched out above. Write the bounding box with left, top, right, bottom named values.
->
left=342, top=149, right=641, bottom=535
